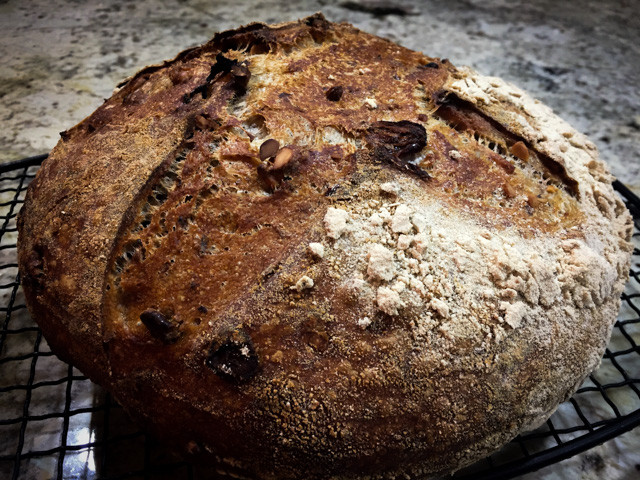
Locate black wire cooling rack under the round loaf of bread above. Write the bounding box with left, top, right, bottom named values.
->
left=0, top=155, right=640, bottom=480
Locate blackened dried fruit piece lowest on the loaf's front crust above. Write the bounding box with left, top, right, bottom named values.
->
left=205, top=331, right=259, bottom=383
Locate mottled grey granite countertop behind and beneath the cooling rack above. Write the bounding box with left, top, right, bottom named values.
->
left=0, top=0, right=640, bottom=480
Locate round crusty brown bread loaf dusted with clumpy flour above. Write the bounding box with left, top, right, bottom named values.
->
left=19, top=15, right=632, bottom=479
